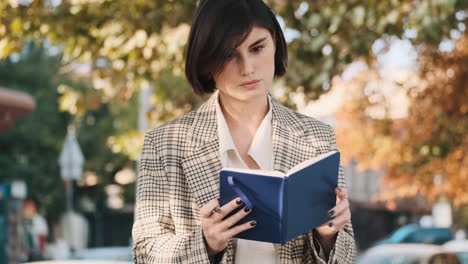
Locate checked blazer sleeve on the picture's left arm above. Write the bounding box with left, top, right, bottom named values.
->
left=132, top=133, right=210, bottom=264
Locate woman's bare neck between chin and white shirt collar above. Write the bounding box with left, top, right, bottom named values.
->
left=219, top=94, right=268, bottom=130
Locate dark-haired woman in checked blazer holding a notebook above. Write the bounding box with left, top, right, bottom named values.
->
left=133, top=0, right=355, bottom=263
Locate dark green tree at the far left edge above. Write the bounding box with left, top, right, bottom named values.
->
left=0, top=43, right=71, bottom=223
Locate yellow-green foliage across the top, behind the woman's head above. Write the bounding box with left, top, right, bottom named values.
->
left=0, top=0, right=468, bottom=107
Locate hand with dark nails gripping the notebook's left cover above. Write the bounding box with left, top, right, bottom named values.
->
left=200, top=198, right=257, bottom=257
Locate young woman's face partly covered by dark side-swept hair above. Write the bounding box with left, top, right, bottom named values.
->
left=214, top=26, right=275, bottom=101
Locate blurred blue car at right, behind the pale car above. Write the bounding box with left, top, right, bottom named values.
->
left=375, top=224, right=453, bottom=245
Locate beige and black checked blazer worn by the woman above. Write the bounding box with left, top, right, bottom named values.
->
left=132, top=93, right=356, bottom=264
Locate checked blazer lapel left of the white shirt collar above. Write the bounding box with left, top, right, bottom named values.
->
left=182, top=93, right=222, bottom=208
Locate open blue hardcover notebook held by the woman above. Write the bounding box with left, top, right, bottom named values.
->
left=220, top=151, right=340, bottom=245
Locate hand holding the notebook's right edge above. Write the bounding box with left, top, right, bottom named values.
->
left=315, top=188, right=351, bottom=240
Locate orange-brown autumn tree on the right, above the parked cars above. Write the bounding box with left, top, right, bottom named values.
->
left=337, top=34, right=468, bottom=206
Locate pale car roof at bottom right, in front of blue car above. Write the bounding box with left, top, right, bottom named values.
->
left=357, top=244, right=462, bottom=264
